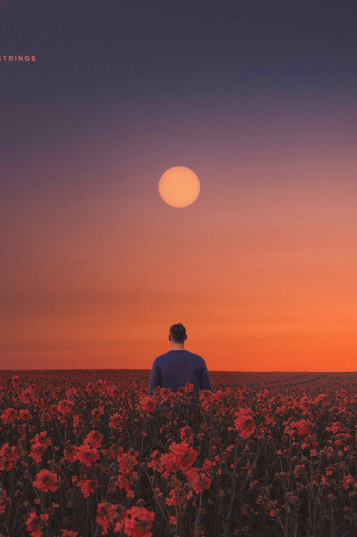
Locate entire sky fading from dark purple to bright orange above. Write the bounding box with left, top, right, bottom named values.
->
left=0, top=0, right=357, bottom=371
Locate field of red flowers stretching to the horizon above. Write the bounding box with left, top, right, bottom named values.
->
left=0, top=370, right=357, bottom=537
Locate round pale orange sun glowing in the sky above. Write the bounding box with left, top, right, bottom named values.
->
left=159, top=166, right=200, bottom=207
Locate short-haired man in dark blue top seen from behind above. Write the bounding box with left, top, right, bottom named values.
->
left=149, top=323, right=212, bottom=396
